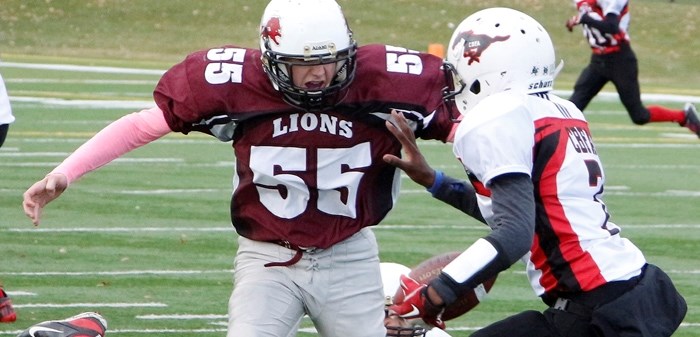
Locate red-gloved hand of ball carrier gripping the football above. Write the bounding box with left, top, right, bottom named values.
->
left=389, top=275, right=445, bottom=329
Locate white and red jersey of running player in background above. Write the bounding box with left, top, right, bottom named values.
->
left=574, top=0, right=630, bottom=53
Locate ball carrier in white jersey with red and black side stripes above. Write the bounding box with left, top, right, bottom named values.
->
left=385, top=8, right=687, bottom=337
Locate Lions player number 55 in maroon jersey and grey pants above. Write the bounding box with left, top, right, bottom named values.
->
left=23, top=0, right=456, bottom=337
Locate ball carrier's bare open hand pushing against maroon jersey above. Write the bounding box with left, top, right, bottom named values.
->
left=384, top=110, right=435, bottom=188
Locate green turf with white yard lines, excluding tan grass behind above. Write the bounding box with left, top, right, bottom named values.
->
left=0, top=59, right=700, bottom=336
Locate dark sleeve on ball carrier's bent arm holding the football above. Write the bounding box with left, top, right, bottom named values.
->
left=430, top=173, right=535, bottom=304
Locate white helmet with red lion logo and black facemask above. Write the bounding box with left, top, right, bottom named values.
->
left=260, top=0, right=357, bottom=111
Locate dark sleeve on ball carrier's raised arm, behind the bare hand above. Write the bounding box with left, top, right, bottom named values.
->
left=430, top=172, right=486, bottom=223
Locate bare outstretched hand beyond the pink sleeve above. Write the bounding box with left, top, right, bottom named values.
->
left=22, top=173, right=68, bottom=225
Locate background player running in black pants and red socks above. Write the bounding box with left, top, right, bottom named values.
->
left=566, top=0, right=700, bottom=137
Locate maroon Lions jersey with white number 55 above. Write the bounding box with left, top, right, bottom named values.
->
left=154, top=45, right=453, bottom=248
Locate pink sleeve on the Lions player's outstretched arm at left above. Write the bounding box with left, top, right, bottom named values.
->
left=51, top=107, right=171, bottom=184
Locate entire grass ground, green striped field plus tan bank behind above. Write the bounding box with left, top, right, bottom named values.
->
left=0, top=0, right=700, bottom=337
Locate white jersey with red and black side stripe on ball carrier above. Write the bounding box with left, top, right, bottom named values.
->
left=454, top=92, right=645, bottom=295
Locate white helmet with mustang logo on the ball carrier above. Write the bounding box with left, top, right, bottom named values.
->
left=446, top=7, right=558, bottom=114
